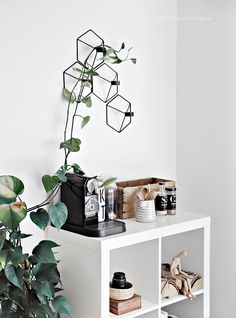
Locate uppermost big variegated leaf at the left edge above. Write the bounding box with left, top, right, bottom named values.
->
left=0, top=176, right=24, bottom=204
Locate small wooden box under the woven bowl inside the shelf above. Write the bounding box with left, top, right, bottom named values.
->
left=110, top=294, right=142, bottom=315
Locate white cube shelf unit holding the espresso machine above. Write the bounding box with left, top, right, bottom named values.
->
left=47, top=211, right=210, bottom=318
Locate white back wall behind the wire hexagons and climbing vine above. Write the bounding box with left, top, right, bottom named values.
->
left=0, top=0, right=177, bottom=248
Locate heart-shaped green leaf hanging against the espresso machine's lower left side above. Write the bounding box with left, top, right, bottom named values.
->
left=48, top=202, right=68, bottom=230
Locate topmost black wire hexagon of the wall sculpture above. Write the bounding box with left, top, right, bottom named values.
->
left=76, top=30, right=105, bottom=68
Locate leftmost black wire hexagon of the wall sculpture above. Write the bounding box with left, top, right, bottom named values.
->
left=63, top=62, right=93, bottom=102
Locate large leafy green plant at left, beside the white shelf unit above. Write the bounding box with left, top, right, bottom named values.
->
left=0, top=176, right=72, bottom=318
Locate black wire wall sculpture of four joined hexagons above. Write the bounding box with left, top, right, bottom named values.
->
left=63, top=29, right=134, bottom=133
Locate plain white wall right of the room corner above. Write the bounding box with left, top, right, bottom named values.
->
left=177, top=0, right=236, bottom=318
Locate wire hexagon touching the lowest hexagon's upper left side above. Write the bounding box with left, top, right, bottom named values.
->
left=93, top=64, right=120, bottom=103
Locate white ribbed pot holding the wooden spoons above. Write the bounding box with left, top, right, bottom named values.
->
left=136, top=200, right=156, bottom=222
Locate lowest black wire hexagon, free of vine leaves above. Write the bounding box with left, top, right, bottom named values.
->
left=106, top=95, right=134, bottom=133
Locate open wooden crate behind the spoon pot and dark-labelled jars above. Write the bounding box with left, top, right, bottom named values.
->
left=116, top=178, right=175, bottom=219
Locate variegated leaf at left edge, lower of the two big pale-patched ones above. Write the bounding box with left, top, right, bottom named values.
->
left=0, top=202, right=27, bottom=230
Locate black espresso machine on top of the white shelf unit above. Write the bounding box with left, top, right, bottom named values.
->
left=61, top=173, right=126, bottom=237
